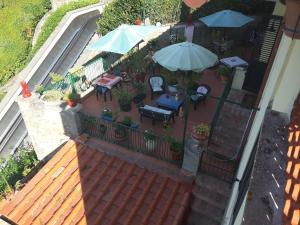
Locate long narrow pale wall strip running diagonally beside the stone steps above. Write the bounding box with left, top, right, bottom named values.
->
left=222, top=35, right=295, bottom=225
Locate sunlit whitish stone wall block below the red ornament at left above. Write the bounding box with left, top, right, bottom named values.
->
left=17, top=94, right=81, bottom=160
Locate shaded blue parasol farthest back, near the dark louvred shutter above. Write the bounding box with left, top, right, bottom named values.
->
left=199, top=10, right=253, bottom=27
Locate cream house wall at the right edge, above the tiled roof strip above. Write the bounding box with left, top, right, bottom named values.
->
left=272, top=38, right=300, bottom=117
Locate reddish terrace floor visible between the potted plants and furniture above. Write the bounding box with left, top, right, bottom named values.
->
left=82, top=66, right=224, bottom=140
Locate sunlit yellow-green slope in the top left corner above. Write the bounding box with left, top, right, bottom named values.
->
left=0, top=0, right=51, bottom=85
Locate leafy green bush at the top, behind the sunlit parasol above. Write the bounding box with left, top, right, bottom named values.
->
left=97, top=0, right=181, bottom=35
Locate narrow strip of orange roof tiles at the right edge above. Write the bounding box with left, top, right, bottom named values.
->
left=283, top=94, right=300, bottom=225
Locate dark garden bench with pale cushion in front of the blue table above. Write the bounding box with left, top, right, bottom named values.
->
left=139, top=105, right=175, bottom=125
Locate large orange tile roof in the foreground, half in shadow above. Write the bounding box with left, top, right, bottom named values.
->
left=0, top=141, right=192, bottom=225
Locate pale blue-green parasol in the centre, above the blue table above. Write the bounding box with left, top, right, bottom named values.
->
left=153, top=42, right=218, bottom=72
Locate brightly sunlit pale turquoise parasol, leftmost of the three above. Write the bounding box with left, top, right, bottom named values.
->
left=87, top=24, right=158, bottom=54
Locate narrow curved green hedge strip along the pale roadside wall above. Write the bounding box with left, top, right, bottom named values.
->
left=31, top=0, right=99, bottom=55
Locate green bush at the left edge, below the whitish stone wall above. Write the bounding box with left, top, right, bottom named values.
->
left=0, top=147, right=38, bottom=199
